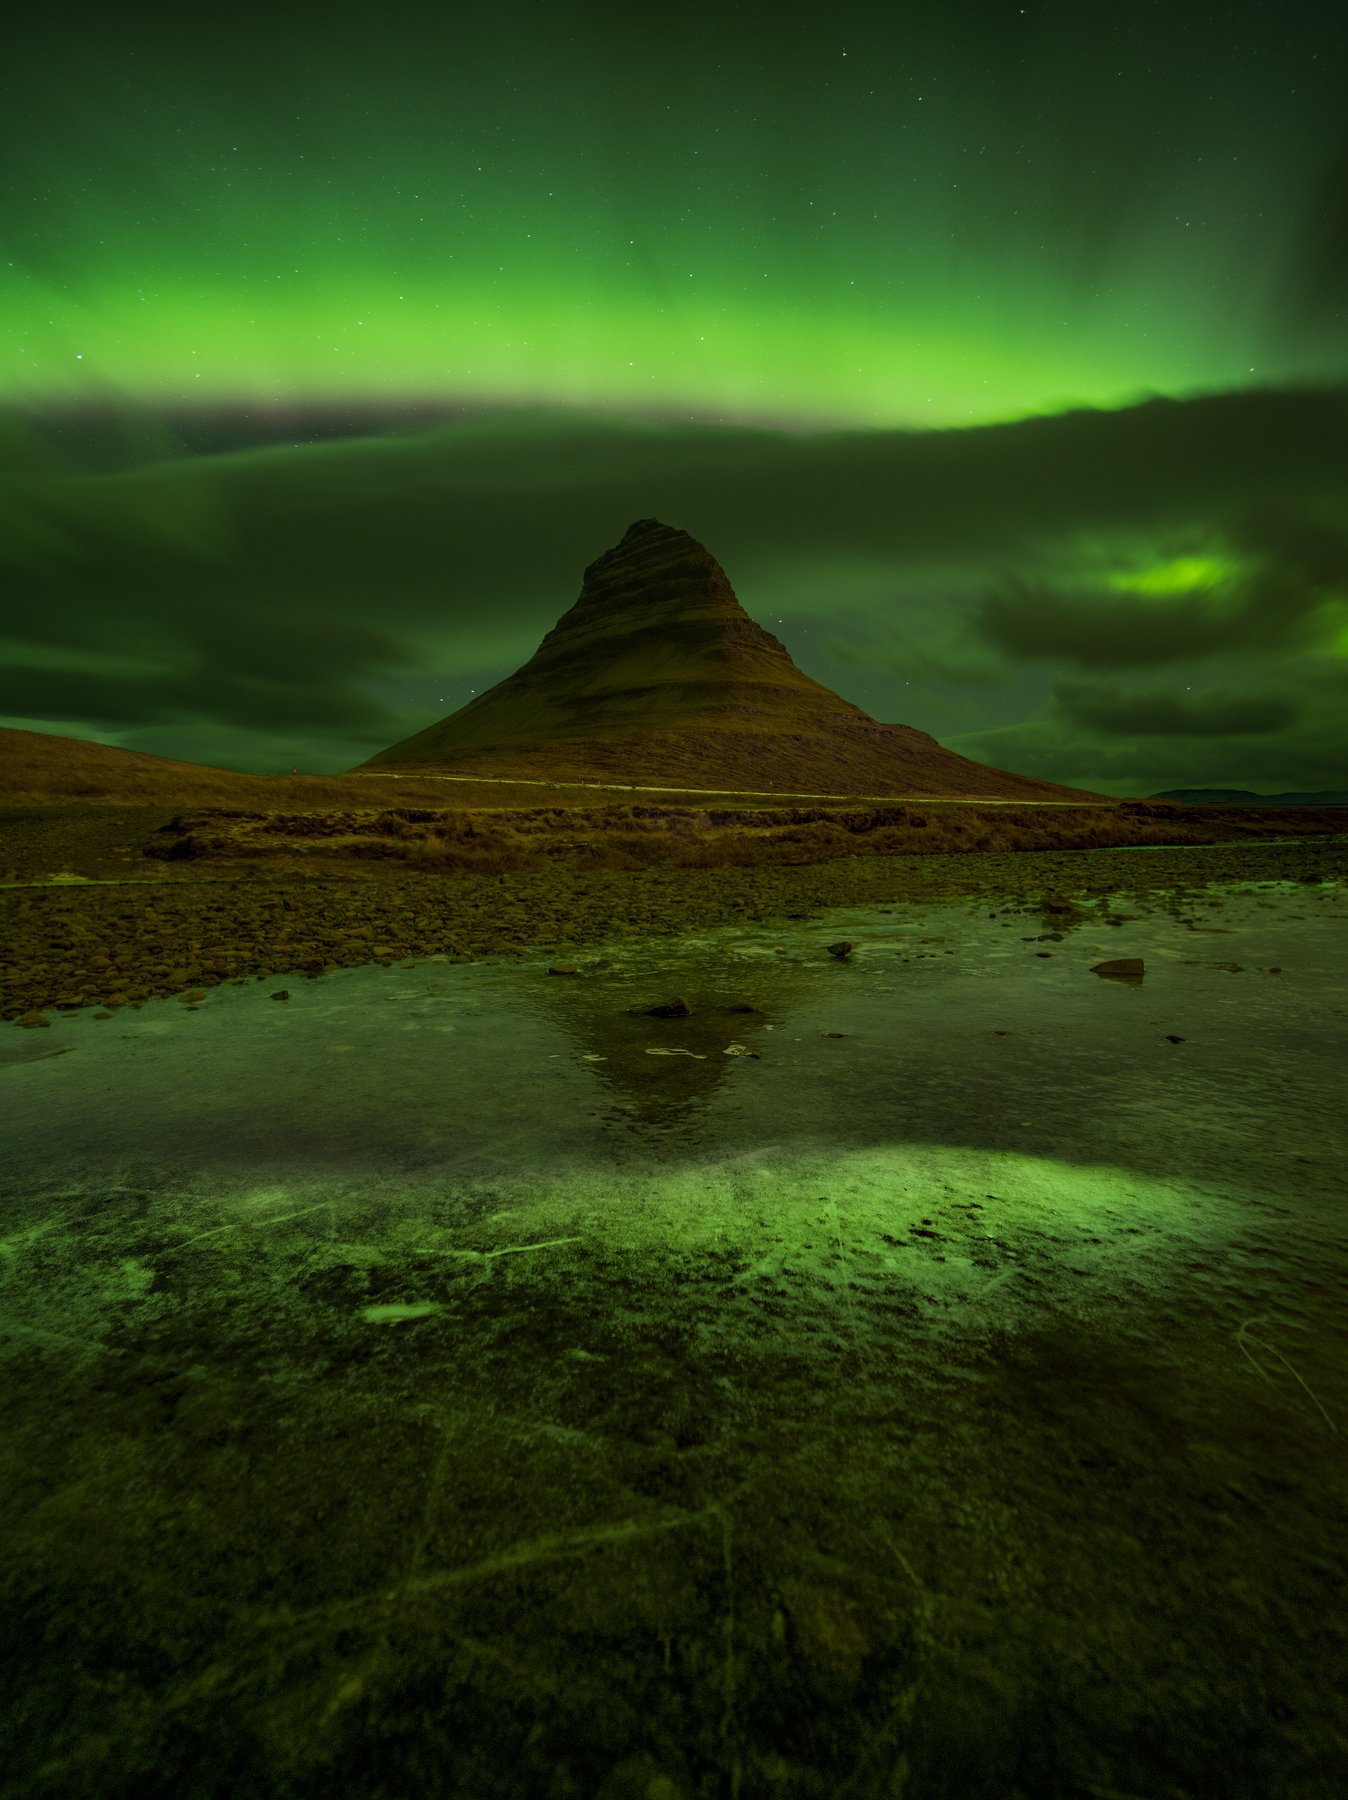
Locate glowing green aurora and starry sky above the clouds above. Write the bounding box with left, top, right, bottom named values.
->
left=0, top=4, right=1348, bottom=427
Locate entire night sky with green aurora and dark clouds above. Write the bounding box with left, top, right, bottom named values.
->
left=0, top=0, right=1348, bottom=794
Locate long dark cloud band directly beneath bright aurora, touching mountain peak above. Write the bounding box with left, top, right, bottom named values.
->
left=11, top=391, right=1348, bottom=586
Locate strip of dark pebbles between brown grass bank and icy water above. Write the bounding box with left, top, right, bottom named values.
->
left=0, top=837, right=1348, bottom=1028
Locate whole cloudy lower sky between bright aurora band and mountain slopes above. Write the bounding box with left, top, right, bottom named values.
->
left=0, top=391, right=1348, bottom=785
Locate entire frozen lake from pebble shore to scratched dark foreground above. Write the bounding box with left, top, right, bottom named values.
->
left=0, top=867, right=1348, bottom=1800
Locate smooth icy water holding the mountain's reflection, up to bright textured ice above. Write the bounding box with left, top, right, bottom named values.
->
left=0, top=871, right=1348, bottom=1184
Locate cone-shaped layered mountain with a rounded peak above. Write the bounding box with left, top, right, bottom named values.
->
left=353, top=518, right=1100, bottom=801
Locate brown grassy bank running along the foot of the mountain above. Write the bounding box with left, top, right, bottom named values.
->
left=0, top=729, right=1348, bottom=880
